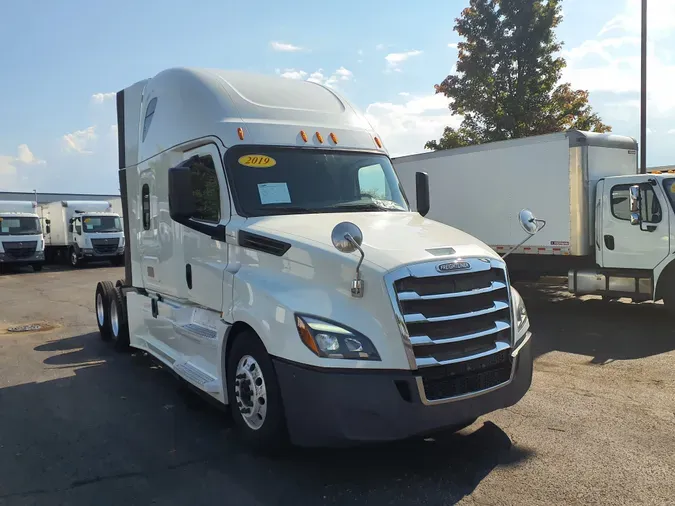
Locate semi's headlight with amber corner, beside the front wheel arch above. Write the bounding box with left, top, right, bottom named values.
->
left=295, top=315, right=380, bottom=360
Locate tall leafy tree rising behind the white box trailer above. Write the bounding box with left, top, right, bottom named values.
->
left=424, top=0, right=611, bottom=150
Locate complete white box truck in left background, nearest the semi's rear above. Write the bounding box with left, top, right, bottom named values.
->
left=40, top=200, right=125, bottom=267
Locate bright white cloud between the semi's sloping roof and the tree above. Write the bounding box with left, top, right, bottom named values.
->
left=366, top=94, right=462, bottom=156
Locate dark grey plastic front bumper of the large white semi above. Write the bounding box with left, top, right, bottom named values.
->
left=274, top=336, right=533, bottom=446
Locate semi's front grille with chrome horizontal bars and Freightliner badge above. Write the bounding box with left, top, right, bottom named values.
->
left=388, top=258, right=512, bottom=401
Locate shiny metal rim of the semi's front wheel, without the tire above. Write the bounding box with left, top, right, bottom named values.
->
left=234, top=355, right=267, bottom=430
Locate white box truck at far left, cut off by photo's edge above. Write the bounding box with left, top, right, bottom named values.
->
left=0, top=200, right=45, bottom=271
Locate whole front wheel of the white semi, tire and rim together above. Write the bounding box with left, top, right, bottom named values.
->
left=227, top=330, right=288, bottom=451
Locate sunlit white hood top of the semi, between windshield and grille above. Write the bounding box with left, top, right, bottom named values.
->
left=245, top=212, right=500, bottom=271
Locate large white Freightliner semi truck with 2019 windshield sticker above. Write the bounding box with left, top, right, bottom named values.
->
left=95, top=68, right=532, bottom=447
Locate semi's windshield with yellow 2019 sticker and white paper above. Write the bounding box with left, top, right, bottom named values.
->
left=225, top=146, right=409, bottom=217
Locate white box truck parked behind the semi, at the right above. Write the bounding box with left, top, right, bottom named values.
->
left=394, top=130, right=675, bottom=307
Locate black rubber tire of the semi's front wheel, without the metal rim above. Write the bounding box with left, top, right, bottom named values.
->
left=227, top=330, right=288, bottom=453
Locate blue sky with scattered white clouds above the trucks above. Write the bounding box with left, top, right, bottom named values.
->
left=0, top=0, right=675, bottom=193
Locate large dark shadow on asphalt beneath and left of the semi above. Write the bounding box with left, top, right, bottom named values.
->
left=0, top=333, right=532, bottom=506
